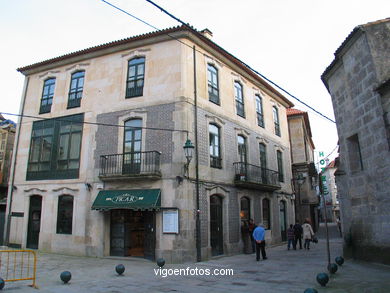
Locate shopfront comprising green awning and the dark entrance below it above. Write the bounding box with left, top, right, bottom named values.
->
left=92, top=189, right=161, bottom=260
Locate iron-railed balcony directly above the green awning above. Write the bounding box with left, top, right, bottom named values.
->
left=99, top=151, right=161, bottom=181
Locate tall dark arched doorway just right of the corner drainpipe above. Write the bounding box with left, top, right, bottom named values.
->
left=210, top=195, right=223, bottom=256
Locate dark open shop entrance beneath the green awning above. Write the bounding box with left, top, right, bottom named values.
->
left=110, top=209, right=156, bottom=260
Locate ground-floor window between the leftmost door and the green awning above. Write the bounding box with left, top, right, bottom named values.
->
left=57, top=195, right=73, bottom=234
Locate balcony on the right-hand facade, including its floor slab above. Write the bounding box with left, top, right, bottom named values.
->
left=233, top=162, right=281, bottom=191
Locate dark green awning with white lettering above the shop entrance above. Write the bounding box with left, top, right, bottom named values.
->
left=91, top=189, right=161, bottom=211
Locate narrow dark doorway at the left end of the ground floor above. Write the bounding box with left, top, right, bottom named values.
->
left=26, top=195, right=42, bottom=249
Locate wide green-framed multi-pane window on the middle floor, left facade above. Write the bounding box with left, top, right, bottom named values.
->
left=27, top=114, right=84, bottom=180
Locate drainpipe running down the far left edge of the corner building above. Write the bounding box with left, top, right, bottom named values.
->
left=4, top=77, right=30, bottom=246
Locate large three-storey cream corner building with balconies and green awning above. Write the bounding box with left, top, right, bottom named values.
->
left=7, top=26, right=294, bottom=262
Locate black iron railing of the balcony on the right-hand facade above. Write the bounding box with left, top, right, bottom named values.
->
left=233, top=162, right=280, bottom=188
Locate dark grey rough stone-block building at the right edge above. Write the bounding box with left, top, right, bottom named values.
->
left=322, top=18, right=390, bottom=264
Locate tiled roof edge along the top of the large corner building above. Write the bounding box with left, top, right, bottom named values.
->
left=17, top=25, right=294, bottom=107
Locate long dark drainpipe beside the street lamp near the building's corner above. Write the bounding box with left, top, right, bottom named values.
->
left=192, top=46, right=202, bottom=262
